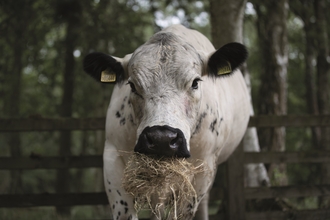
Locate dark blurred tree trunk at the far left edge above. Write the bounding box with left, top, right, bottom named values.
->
left=0, top=2, right=31, bottom=193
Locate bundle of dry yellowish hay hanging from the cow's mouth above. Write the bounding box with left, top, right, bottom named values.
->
left=123, top=153, right=205, bottom=219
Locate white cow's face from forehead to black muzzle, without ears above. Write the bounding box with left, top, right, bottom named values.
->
left=128, top=36, right=204, bottom=157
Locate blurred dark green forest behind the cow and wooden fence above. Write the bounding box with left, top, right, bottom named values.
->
left=0, top=0, right=330, bottom=219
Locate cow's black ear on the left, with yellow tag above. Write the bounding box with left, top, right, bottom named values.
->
left=83, top=52, right=125, bottom=83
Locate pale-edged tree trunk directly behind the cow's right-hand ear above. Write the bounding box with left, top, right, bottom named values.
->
left=210, top=0, right=269, bottom=187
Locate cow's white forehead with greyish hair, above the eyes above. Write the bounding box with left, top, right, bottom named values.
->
left=128, top=33, right=203, bottom=87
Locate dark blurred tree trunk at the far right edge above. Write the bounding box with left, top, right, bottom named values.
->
left=315, top=0, right=330, bottom=208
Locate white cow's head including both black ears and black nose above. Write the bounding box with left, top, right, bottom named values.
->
left=84, top=33, right=247, bottom=157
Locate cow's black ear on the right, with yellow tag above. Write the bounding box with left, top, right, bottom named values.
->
left=207, top=43, right=248, bottom=76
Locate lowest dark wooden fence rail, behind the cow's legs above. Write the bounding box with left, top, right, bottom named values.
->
left=0, top=185, right=330, bottom=207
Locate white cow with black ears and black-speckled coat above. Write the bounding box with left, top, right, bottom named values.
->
left=83, top=25, right=250, bottom=220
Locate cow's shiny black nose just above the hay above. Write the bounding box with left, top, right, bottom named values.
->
left=134, top=126, right=190, bottom=158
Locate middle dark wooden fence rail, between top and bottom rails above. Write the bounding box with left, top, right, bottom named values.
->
left=0, top=151, right=330, bottom=170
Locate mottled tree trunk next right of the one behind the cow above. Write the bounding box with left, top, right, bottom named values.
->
left=255, top=0, right=288, bottom=185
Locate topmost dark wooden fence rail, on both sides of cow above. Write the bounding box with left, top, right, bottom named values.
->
left=0, top=115, right=330, bottom=132
